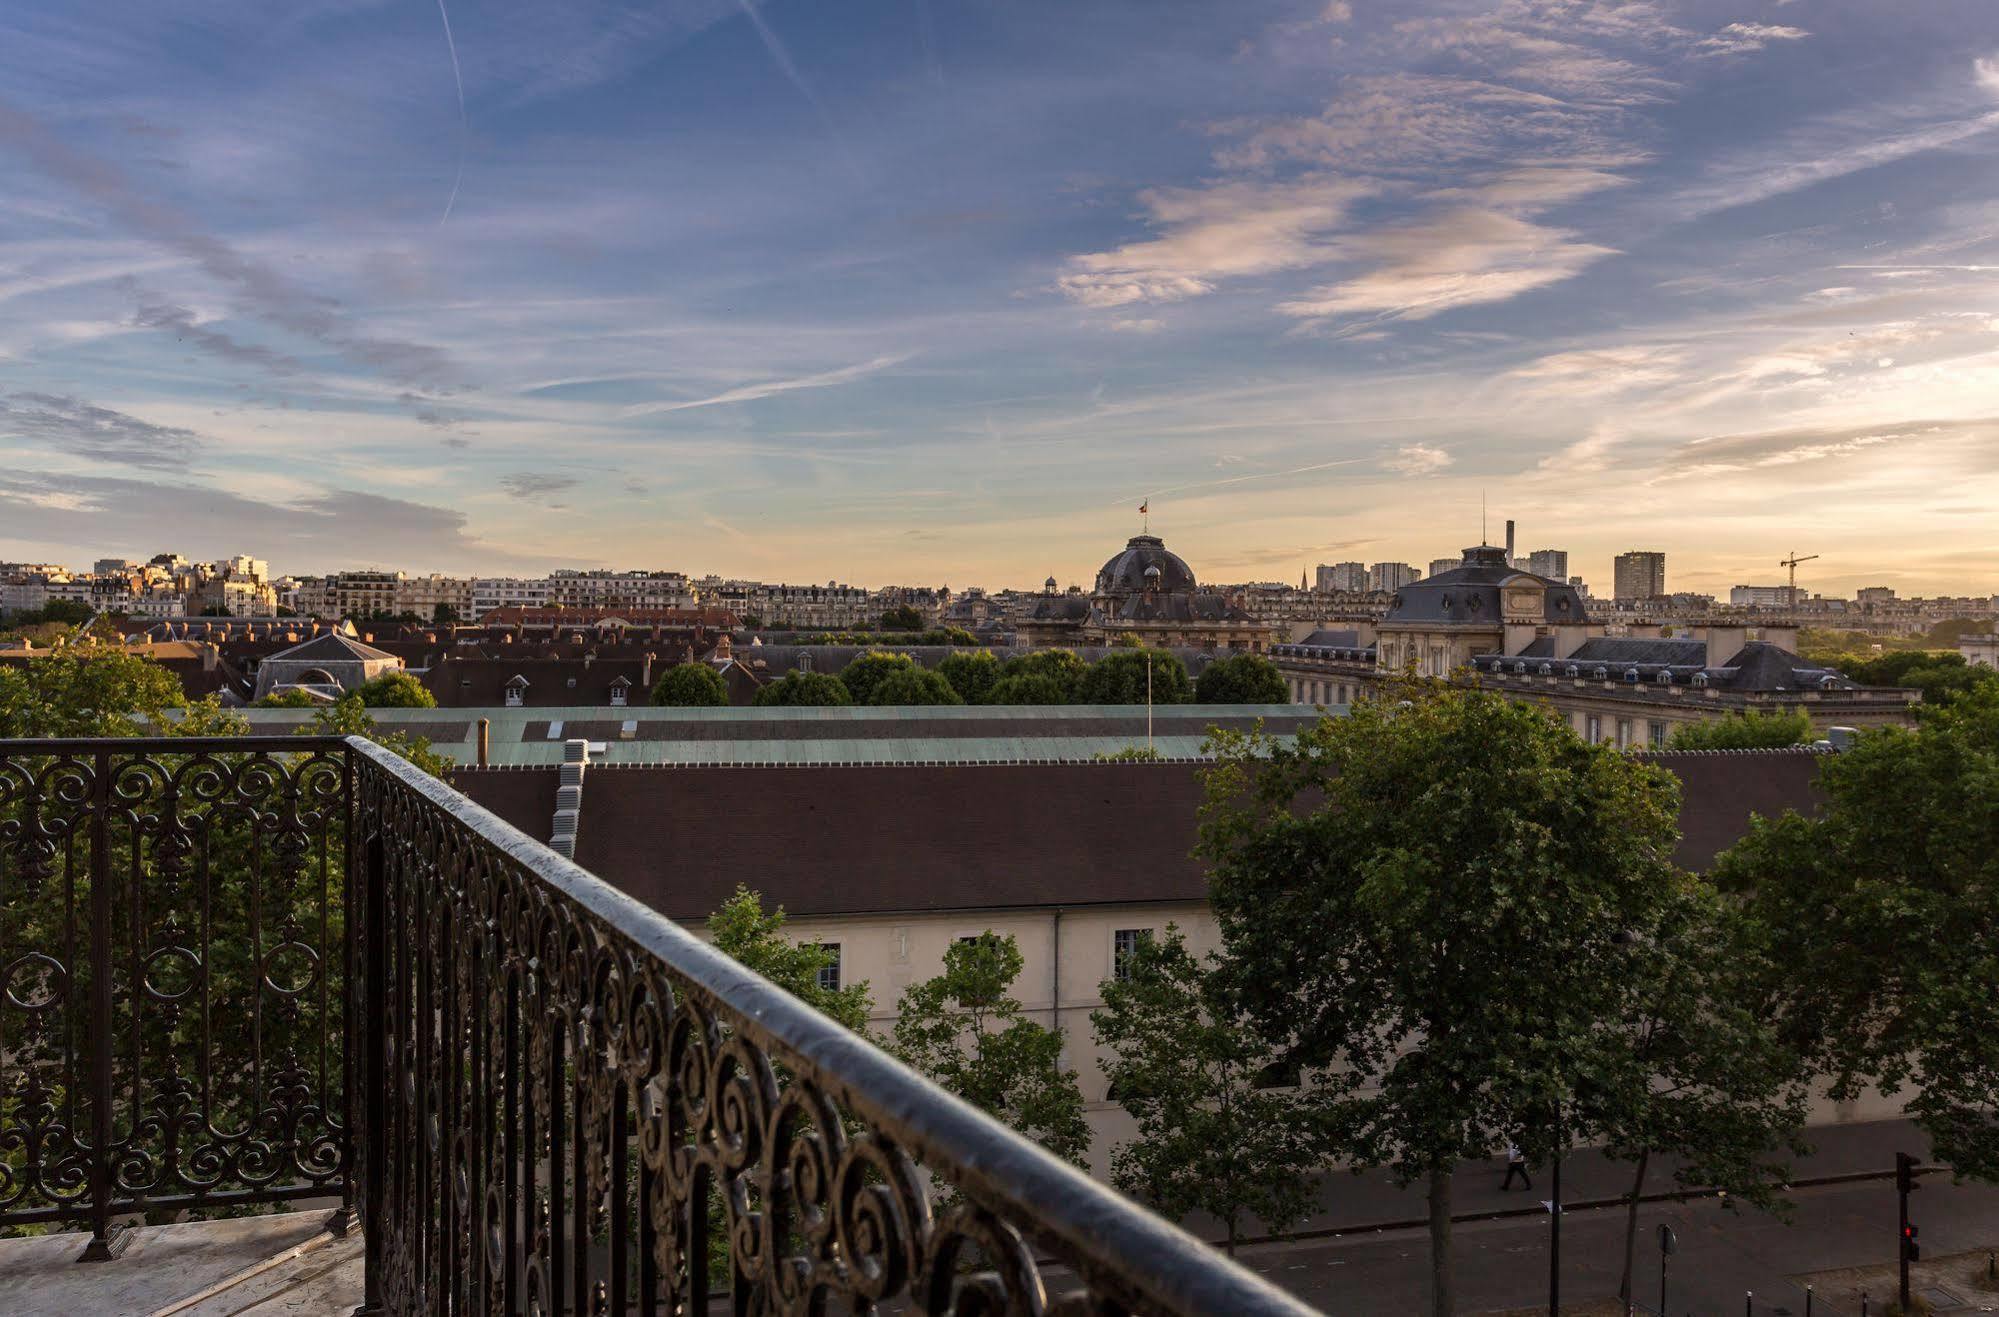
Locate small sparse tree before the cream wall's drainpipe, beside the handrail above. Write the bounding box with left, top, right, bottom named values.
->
left=882, top=931, right=1089, bottom=1161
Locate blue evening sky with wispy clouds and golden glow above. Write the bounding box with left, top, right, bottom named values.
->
left=0, top=0, right=1999, bottom=594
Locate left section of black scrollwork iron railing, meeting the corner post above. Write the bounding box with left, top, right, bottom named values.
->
left=0, top=737, right=350, bottom=1257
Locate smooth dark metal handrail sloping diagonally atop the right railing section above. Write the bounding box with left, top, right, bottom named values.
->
left=348, top=737, right=1315, bottom=1317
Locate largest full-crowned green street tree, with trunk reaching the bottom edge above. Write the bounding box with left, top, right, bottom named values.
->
left=1199, top=681, right=1691, bottom=1317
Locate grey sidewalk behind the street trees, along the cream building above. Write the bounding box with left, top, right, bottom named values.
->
left=1185, top=1121, right=1929, bottom=1239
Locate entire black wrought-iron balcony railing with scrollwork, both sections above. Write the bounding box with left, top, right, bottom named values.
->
left=0, top=737, right=1309, bottom=1317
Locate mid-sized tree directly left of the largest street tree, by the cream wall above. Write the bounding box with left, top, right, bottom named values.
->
left=1089, top=925, right=1317, bottom=1257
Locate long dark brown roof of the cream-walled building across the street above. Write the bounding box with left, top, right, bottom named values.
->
left=454, top=751, right=1817, bottom=919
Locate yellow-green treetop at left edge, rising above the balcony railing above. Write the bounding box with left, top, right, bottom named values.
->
left=0, top=644, right=188, bottom=737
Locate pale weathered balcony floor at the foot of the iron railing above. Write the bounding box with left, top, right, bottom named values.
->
left=0, top=1211, right=362, bottom=1317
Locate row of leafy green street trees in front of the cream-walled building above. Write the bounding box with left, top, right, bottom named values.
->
left=703, top=683, right=1999, bottom=1315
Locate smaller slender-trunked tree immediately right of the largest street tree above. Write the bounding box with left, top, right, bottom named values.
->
left=1575, top=883, right=1809, bottom=1305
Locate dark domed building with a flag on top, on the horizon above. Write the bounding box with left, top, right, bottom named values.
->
left=1015, top=534, right=1275, bottom=654
